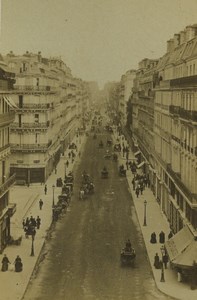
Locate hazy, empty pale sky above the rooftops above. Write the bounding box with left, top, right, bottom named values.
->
left=0, top=0, right=197, bottom=86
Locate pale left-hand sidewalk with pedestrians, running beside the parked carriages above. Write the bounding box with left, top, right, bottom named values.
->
left=0, top=135, right=86, bottom=300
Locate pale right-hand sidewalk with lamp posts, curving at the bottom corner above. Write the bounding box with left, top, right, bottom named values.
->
left=115, top=134, right=197, bottom=300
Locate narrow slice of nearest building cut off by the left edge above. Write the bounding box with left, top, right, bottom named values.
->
left=0, top=55, right=16, bottom=253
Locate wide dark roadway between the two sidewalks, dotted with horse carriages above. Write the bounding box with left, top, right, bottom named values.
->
left=23, top=127, right=171, bottom=300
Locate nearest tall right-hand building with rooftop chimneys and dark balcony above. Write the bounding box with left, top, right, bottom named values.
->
left=154, top=25, right=197, bottom=232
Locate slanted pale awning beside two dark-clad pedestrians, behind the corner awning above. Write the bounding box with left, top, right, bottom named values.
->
left=165, top=226, right=194, bottom=262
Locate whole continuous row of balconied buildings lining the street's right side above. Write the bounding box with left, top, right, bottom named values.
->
left=131, top=25, right=197, bottom=235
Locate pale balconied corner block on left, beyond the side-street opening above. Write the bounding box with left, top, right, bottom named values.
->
left=5, top=51, right=89, bottom=184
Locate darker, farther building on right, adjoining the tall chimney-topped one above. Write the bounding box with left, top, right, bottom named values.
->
left=131, top=58, right=158, bottom=177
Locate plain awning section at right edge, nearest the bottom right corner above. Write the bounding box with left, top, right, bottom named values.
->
left=173, top=241, right=197, bottom=268
